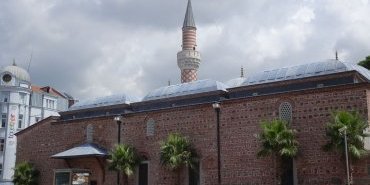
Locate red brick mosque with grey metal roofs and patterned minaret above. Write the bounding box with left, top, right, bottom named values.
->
left=16, top=0, right=370, bottom=185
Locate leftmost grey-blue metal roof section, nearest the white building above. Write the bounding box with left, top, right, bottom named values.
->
left=69, top=94, right=140, bottom=111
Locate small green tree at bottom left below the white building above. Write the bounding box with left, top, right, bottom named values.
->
left=13, top=162, right=39, bottom=185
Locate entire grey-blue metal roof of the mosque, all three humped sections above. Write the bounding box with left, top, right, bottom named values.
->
left=69, top=60, right=370, bottom=111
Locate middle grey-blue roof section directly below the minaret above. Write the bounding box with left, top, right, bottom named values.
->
left=143, top=79, right=229, bottom=101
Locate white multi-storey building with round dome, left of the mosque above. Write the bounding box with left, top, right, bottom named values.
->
left=0, top=62, right=72, bottom=185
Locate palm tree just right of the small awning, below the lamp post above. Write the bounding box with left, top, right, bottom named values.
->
left=108, top=144, right=140, bottom=185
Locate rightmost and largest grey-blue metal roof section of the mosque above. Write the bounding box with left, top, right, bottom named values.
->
left=226, top=59, right=370, bottom=87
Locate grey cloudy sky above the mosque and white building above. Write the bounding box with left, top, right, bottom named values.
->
left=0, top=0, right=370, bottom=100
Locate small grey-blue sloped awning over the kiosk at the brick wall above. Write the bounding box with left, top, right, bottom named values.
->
left=51, top=143, right=108, bottom=159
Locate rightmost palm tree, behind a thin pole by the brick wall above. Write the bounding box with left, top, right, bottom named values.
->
left=323, top=111, right=370, bottom=159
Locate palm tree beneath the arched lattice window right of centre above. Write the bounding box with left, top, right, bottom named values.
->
left=257, top=119, right=298, bottom=184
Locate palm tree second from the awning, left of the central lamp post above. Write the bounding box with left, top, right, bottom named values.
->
left=160, top=133, right=197, bottom=185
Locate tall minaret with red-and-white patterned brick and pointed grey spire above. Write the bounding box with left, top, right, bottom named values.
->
left=177, top=0, right=200, bottom=83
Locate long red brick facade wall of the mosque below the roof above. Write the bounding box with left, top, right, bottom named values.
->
left=17, top=84, right=370, bottom=185
